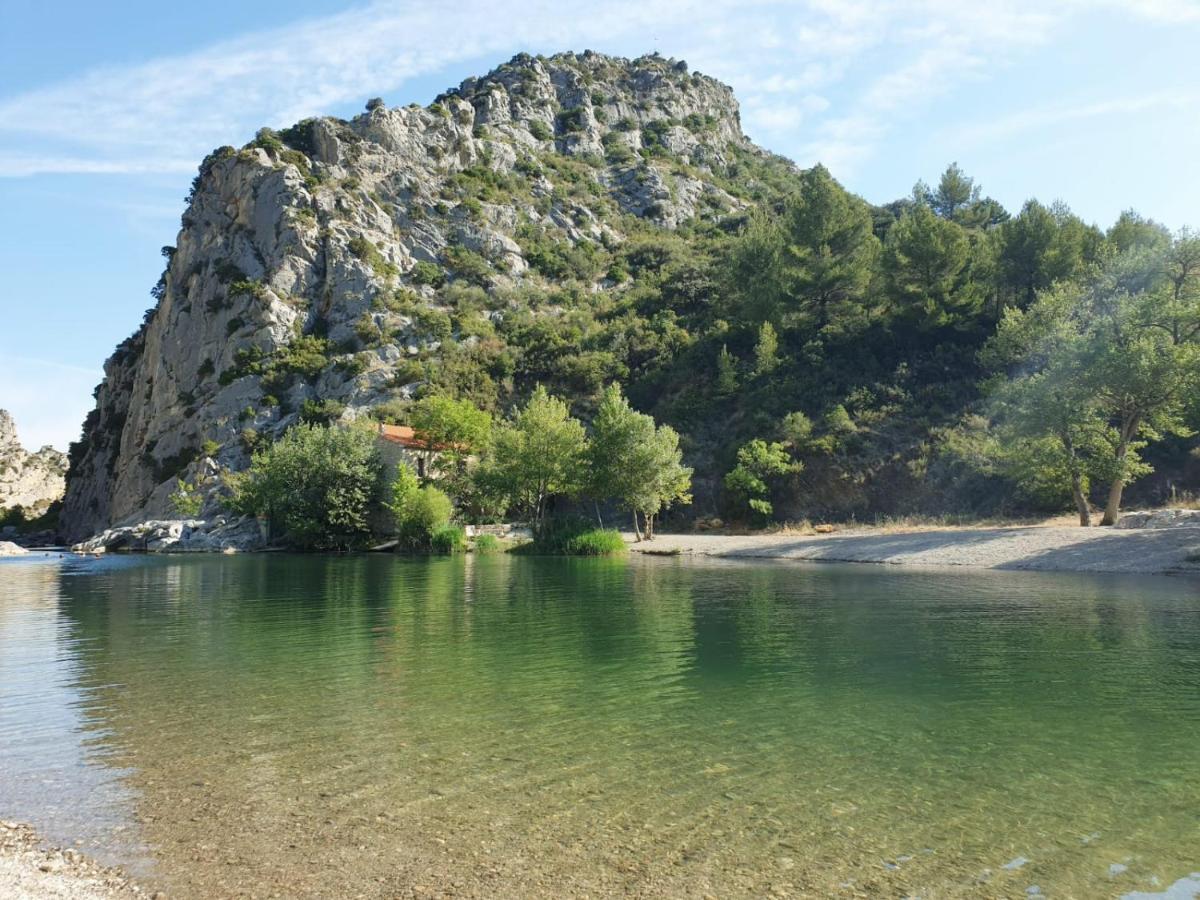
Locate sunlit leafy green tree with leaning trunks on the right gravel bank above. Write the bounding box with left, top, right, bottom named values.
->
left=984, top=247, right=1200, bottom=524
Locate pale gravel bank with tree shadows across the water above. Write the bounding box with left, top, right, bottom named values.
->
left=631, top=524, right=1200, bottom=575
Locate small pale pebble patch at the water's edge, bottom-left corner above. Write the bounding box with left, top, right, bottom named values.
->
left=0, top=822, right=142, bottom=900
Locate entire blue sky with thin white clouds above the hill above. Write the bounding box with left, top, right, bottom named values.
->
left=0, top=0, right=1200, bottom=448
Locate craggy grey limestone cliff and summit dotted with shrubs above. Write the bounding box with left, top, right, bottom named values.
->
left=62, top=52, right=790, bottom=539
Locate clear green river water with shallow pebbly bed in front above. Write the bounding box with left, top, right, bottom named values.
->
left=0, top=556, right=1200, bottom=898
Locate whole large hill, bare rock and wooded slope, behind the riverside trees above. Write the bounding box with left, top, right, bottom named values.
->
left=65, top=53, right=1200, bottom=535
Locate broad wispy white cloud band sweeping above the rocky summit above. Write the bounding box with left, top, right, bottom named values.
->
left=0, top=0, right=1185, bottom=176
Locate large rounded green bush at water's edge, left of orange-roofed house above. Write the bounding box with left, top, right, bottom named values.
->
left=232, top=424, right=380, bottom=550
